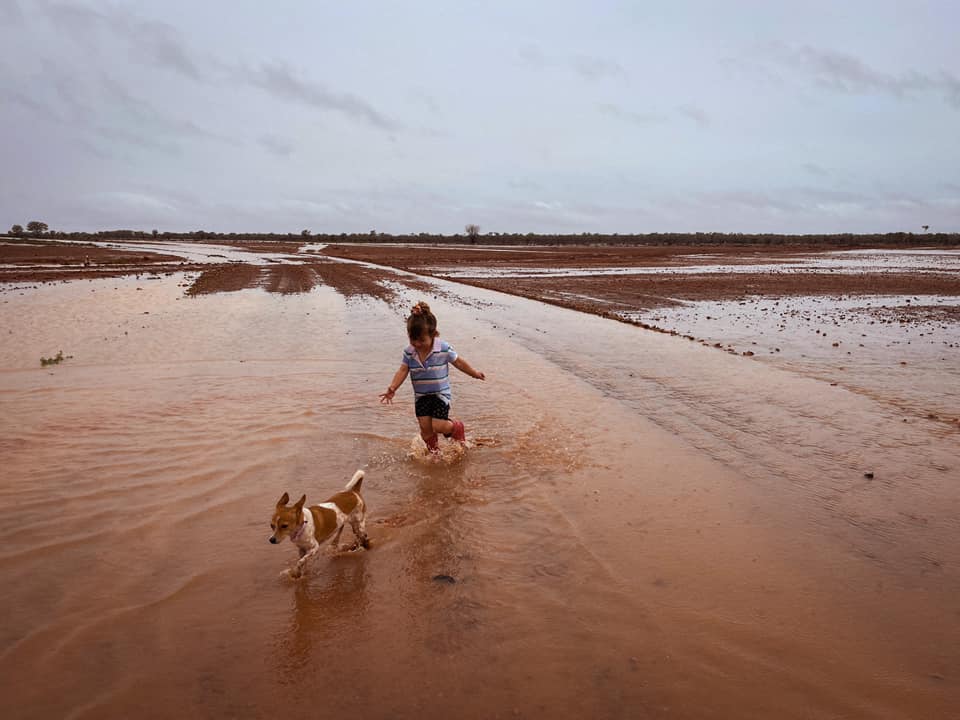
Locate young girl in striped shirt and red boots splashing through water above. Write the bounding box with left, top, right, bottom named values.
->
left=380, top=300, right=485, bottom=453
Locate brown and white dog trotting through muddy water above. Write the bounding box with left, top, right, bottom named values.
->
left=270, top=470, right=370, bottom=578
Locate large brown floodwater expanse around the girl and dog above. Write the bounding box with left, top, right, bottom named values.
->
left=0, top=268, right=960, bottom=719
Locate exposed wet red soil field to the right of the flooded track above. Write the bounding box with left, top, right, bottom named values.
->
left=324, top=245, right=960, bottom=329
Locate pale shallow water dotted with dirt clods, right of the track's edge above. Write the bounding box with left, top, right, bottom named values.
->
left=632, top=295, right=960, bottom=422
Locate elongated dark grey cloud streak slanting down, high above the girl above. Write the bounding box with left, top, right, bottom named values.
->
left=238, top=62, right=399, bottom=130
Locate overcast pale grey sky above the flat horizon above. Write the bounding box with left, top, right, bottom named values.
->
left=0, top=0, right=960, bottom=233
